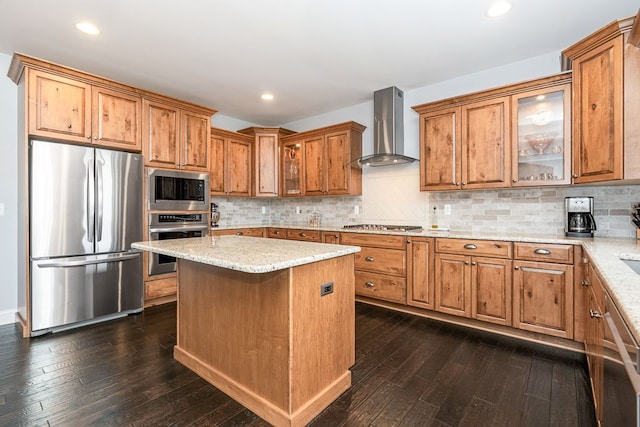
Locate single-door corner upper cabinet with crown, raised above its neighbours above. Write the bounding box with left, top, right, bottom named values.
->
left=238, top=127, right=295, bottom=197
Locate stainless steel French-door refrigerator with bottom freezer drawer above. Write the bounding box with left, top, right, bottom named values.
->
left=29, top=140, right=144, bottom=336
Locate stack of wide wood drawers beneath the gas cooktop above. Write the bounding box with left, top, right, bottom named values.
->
left=340, top=233, right=407, bottom=304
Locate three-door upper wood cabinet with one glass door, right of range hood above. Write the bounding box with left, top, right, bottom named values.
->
left=413, top=73, right=571, bottom=191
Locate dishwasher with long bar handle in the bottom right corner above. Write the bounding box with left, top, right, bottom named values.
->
left=602, top=295, right=640, bottom=427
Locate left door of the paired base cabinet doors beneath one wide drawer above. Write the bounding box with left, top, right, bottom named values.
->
left=435, top=254, right=471, bottom=317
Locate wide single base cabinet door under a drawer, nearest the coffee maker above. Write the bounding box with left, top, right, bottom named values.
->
left=513, top=261, right=573, bottom=339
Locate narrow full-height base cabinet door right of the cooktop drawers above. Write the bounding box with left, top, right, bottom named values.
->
left=407, top=238, right=435, bottom=310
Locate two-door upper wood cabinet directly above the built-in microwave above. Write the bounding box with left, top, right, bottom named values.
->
left=142, top=99, right=211, bottom=172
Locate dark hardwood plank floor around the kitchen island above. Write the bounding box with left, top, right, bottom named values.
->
left=0, top=304, right=596, bottom=427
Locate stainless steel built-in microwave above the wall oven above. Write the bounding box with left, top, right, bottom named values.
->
left=147, top=168, right=210, bottom=211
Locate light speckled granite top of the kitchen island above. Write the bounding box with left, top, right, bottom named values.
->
left=131, top=236, right=360, bottom=273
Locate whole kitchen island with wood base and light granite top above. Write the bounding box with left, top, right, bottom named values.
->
left=132, top=236, right=360, bottom=426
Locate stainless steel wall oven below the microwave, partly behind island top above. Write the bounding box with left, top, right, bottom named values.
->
left=148, top=213, right=209, bottom=276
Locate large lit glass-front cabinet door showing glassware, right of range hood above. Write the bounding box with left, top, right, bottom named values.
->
left=511, top=83, right=571, bottom=187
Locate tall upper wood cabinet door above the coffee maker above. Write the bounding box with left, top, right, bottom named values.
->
left=573, top=36, right=624, bottom=183
